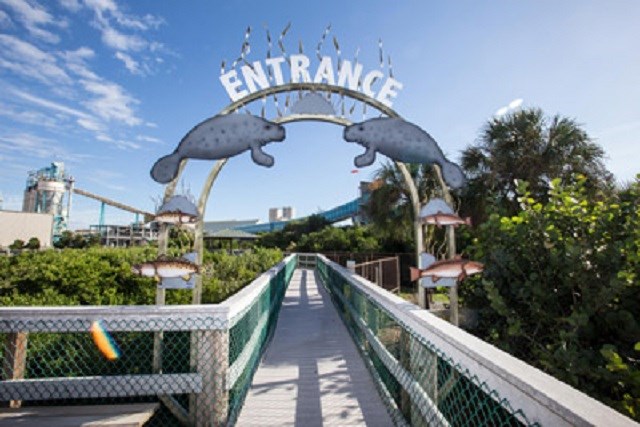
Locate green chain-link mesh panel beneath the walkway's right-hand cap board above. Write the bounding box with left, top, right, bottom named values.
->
left=317, top=257, right=532, bottom=426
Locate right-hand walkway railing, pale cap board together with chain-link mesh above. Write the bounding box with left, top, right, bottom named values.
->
left=318, top=254, right=637, bottom=426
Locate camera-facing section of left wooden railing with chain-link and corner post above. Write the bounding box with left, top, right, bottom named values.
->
left=0, top=315, right=228, bottom=425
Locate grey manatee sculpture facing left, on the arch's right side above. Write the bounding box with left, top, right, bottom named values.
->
left=344, top=117, right=466, bottom=188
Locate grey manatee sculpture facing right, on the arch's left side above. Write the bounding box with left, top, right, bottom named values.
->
left=151, top=114, right=285, bottom=184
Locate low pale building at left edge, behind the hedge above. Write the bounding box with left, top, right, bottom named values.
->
left=0, top=211, right=53, bottom=248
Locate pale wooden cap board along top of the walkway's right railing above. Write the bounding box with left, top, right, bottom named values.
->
left=318, top=254, right=638, bottom=426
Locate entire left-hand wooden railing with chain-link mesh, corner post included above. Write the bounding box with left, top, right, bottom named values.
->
left=0, top=256, right=296, bottom=426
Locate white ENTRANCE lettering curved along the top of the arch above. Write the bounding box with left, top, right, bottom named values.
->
left=220, top=53, right=402, bottom=107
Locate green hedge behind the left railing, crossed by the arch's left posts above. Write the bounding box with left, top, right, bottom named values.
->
left=0, top=247, right=282, bottom=306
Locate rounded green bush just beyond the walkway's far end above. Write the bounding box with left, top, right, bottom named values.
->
left=297, top=227, right=380, bottom=252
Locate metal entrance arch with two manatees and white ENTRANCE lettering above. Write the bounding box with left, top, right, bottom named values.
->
left=151, top=24, right=476, bottom=324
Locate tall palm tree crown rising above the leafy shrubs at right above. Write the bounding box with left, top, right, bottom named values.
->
left=462, top=108, right=613, bottom=219
